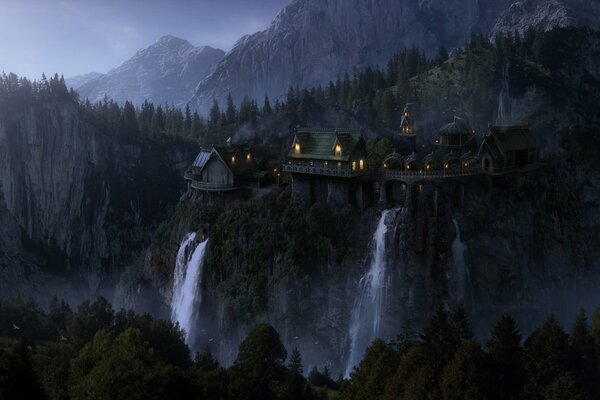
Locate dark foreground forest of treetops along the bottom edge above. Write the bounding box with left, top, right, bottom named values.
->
left=0, top=297, right=600, bottom=400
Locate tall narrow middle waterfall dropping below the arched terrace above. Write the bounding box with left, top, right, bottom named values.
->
left=346, top=209, right=398, bottom=377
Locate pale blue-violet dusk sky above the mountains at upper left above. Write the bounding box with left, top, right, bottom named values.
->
left=0, top=0, right=291, bottom=79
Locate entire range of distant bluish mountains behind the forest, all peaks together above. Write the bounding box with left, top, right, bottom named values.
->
left=67, top=0, right=600, bottom=113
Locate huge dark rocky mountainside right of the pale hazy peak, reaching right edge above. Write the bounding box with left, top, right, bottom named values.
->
left=190, top=0, right=600, bottom=112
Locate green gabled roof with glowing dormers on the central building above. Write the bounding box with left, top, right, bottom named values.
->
left=288, top=129, right=365, bottom=161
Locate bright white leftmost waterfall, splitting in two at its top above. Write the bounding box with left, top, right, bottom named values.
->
left=171, top=232, right=208, bottom=344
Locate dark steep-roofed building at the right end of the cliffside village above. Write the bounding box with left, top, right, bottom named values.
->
left=479, top=126, right=538, bottom=173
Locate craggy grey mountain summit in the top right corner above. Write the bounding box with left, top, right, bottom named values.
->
left=490, top=0, right=600, bottom=38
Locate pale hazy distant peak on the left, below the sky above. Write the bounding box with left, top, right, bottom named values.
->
left=77, top=35, right=225, bottom=106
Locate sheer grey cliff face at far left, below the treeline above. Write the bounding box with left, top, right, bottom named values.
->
left=0, top=103, right=194, bottom=294
